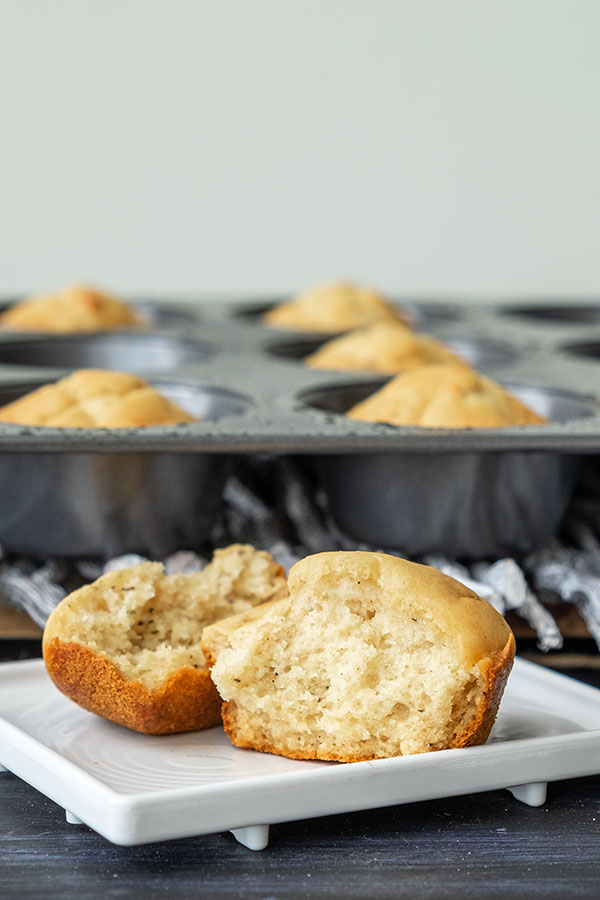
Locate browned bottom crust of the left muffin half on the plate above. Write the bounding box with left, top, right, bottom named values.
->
left=44, top=637, right=221, bottom=734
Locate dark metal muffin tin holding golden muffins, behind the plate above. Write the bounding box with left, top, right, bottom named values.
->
left=0, top=300, right=600, bottom=557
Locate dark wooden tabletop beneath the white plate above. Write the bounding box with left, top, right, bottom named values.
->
left=0, top=640, right=600, bottom=900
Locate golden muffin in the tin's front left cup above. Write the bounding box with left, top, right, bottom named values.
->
left=0, top=369, right=196, bottom=428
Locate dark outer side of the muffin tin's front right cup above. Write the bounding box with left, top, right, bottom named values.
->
left=318, top=453, right=580, bottom=559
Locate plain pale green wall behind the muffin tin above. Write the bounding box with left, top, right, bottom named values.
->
left=0, top=0, right=600, bottom=297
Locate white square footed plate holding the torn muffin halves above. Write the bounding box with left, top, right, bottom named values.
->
left=0, top=659, right=600, bottom=849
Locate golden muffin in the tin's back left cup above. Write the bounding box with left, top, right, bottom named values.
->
left=0, top=285, right=145, bottom=334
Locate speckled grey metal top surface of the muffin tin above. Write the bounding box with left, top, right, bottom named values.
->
left=0, top=301, right=600, bottom=453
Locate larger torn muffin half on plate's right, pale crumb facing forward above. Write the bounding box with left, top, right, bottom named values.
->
left=202, top=551, right=515, bottom=762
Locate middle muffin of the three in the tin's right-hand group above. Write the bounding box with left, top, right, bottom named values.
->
left=304, top=321, right=462, bottom=374
